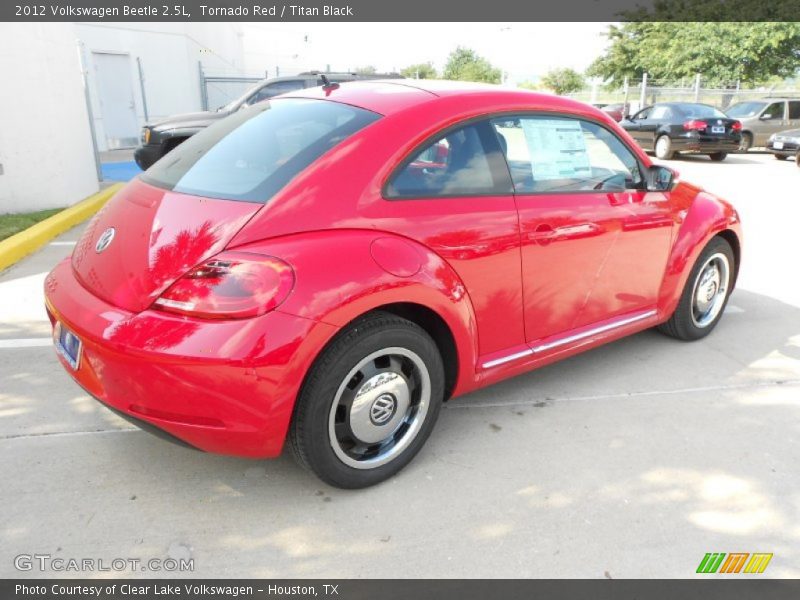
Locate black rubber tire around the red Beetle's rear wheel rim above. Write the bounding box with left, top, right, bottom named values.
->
left=289, top=312, right=445, bottom=489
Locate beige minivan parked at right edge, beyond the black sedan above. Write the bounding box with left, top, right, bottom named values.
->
left=726, top=98, right=800, bottom=152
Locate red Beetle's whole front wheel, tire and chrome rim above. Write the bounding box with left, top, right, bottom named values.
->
left=659, top=237, right=736, bottom=341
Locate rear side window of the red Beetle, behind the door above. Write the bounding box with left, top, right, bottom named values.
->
left=385, top=121, right=513, bottom=199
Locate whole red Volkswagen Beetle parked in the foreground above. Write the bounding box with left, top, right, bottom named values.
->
left=45, top=81, right=741, bottom=488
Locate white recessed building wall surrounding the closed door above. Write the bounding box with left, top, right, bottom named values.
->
left=74, top=23, right=244, bottom=152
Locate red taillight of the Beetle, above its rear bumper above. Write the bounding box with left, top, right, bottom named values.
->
left=154, top=252, right=294, bottom=319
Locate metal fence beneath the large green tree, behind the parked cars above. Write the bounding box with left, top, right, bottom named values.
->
left=570, top=76, right=800, bottom=113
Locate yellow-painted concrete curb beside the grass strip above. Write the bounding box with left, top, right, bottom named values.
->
left=0, top=183, right=125, bottom=271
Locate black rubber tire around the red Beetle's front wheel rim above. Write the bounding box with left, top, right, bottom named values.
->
left=658, top=236, right=736, bottom=341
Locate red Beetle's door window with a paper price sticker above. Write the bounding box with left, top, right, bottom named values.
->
left=492, top=116, right=643, bottom=194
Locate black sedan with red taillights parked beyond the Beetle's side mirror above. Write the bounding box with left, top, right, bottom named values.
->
left=620, top=102, right=742, bottom=161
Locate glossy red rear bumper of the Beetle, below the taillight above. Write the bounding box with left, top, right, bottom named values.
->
left=45, top=261, right=335, bottom=457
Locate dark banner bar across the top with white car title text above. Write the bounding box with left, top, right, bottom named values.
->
left=0, top=0, right=800, bottom=22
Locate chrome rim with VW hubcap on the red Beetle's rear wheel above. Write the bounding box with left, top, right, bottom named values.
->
left=328, top=348, right=431, bottom=469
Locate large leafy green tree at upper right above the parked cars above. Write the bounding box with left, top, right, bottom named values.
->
left=587, top=20, right=800, bottom=85
